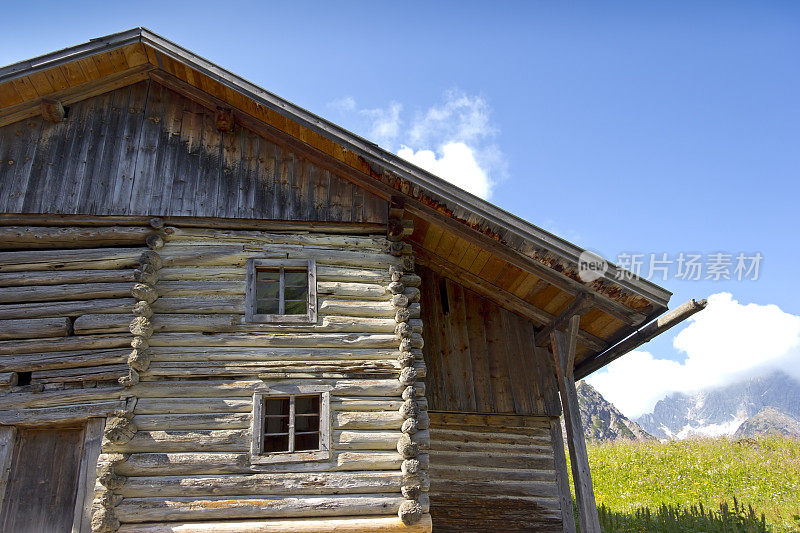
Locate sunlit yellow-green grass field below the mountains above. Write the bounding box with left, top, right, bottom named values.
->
left=564, top=437, right=800, bottom=532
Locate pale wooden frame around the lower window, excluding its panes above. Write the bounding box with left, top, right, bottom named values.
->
left=250, top=384, right=331, bottom=464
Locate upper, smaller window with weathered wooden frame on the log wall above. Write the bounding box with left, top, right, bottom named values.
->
left=245, top=258, right=317, bottom=324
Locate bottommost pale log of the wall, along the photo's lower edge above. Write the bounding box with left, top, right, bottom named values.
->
left=119, top=514, right=433, bottom=533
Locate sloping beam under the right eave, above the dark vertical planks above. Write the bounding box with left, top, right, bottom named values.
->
left=414, top=247, right=608, bottom=351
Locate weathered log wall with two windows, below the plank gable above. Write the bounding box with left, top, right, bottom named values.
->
left=0, top=219, right=430, bottom=531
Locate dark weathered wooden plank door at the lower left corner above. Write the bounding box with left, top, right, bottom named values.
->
left=0, top=428, right=83, bottom=533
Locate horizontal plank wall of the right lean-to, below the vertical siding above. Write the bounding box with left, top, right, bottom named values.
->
left=429, top=411, right=562, bottom=532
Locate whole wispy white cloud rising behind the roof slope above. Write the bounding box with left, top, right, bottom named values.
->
left=329, top=90, right=506, bottom=198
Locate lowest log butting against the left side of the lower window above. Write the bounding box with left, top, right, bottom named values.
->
left=104, top=428, right=252, bottom=453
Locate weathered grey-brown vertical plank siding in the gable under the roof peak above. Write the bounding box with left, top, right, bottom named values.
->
left=0, top=81, right=386, bottom=223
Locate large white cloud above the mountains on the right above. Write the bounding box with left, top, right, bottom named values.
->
left=587, top=292, right=800, bottom=417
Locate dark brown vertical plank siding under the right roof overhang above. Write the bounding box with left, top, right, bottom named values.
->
left=418, top=267, right=561, bottom=416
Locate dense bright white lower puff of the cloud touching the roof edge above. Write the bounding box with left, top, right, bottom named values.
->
left=397, top=142, right=492, bottom=198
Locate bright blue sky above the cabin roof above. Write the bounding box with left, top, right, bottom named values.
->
left=0, top=1, right=800, bottom=420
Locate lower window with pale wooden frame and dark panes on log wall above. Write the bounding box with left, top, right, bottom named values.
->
left=250, top=384, right=331, bottom=464
